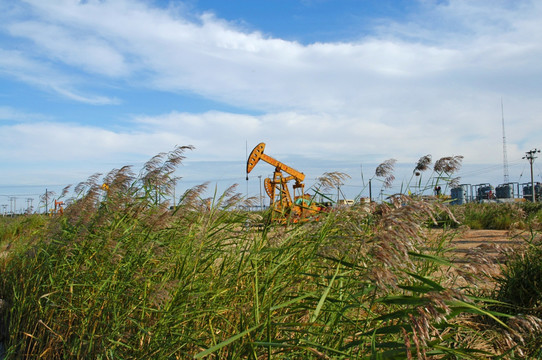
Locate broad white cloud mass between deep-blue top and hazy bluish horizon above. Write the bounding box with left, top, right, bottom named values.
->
left=0, top=0, right=542, bottom=190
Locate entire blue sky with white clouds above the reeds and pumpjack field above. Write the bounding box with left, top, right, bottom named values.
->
left=0, top=0, right=542, bottom=210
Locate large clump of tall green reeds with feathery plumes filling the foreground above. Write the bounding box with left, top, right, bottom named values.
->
left=0, top=149, right=540, bottom=359
